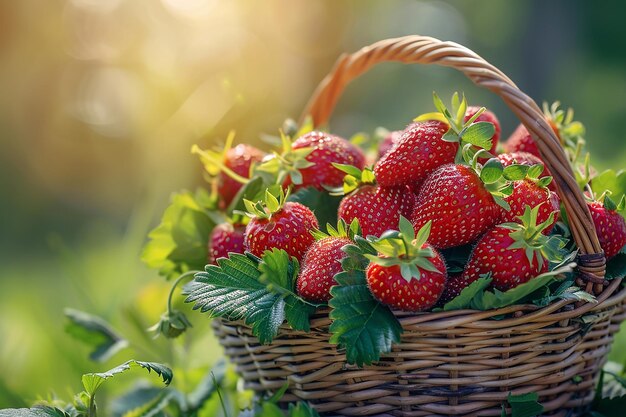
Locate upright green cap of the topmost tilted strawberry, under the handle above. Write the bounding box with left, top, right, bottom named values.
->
left=413, top=92, right=495, bottom=157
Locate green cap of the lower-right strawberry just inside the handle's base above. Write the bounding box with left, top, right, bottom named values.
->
left=500, top=203, right=567, bottom=269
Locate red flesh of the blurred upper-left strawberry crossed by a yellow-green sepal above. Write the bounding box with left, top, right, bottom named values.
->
left=217, top=144, right=265, bottom=208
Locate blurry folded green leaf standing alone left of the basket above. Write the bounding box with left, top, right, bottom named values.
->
left=65, top=308, right=128, bottom=362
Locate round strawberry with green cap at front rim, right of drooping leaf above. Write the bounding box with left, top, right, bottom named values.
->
left=366, top=217, right=447, bottom=311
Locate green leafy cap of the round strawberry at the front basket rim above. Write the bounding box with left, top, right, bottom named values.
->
left=364, top=216, right=442, bottom=281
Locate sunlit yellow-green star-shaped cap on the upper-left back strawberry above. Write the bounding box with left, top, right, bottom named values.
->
left=257, top=130, right=315, bottom=185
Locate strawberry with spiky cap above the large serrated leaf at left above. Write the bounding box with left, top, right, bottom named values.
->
left=243, top=189, right=318, bottom=261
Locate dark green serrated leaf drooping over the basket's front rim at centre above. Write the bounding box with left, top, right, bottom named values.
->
left=328, top=236, right=402, bottom=366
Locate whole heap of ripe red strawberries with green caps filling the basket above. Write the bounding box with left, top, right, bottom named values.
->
left=204, top=94, right=626, bottom=311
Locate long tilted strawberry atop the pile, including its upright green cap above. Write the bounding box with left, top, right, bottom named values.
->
left=374, top=93, right=494, bottom=189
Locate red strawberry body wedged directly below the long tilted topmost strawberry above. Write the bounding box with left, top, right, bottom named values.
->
left=337, top=185, right=416, bottom=236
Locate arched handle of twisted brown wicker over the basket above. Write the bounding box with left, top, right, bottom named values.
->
left=303, top=35, right=606, bottom=294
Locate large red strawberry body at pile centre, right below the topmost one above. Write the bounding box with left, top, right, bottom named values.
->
left=411, top=164, right=501, bottom=249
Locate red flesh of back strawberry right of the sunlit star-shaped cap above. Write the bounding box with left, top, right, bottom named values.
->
left=291, top=132, right=365, bottom=191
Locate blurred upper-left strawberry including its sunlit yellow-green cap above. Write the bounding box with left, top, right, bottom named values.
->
left=191, top=132, right=265, bottom=210
